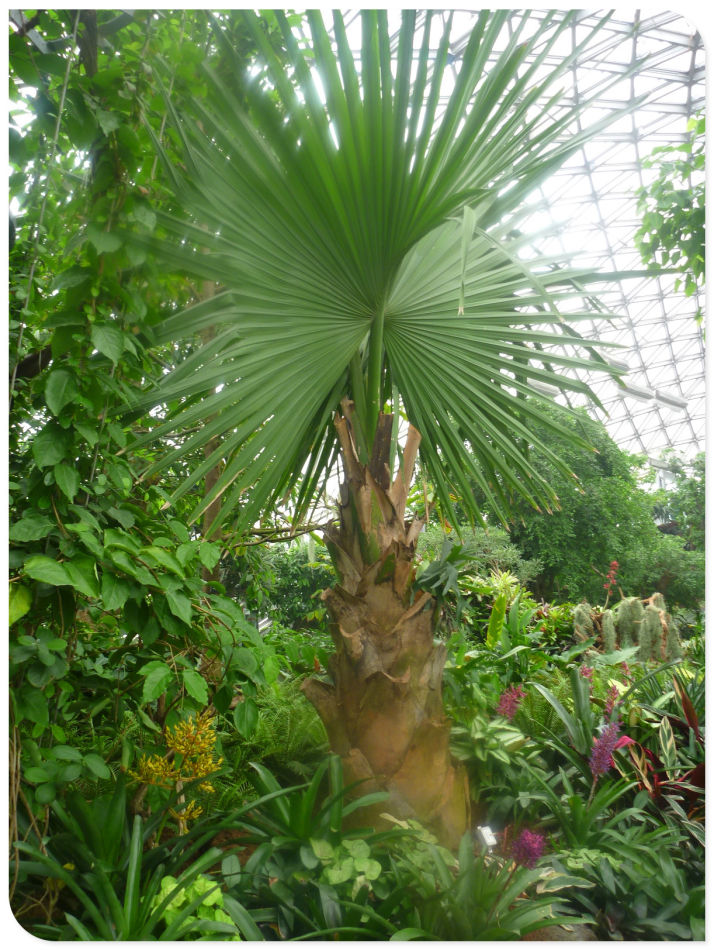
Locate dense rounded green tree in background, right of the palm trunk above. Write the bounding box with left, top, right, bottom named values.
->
left=484, top=407, right=704, bottom=607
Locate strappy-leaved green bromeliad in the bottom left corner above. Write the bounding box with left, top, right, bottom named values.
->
left=15, top=782, right=250, bottom=940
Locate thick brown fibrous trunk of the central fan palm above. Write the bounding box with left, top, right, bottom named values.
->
left=303, top=403, right=469, bottom=847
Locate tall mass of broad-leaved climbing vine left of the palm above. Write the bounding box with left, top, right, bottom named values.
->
left=9, top=11, right=277, bottom=856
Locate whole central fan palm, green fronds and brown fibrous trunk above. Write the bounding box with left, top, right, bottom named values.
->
left=131, top=11, right=644, bottom=843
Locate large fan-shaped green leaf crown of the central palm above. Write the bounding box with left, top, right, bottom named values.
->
left=134, top=11, right=634, bottom=528
